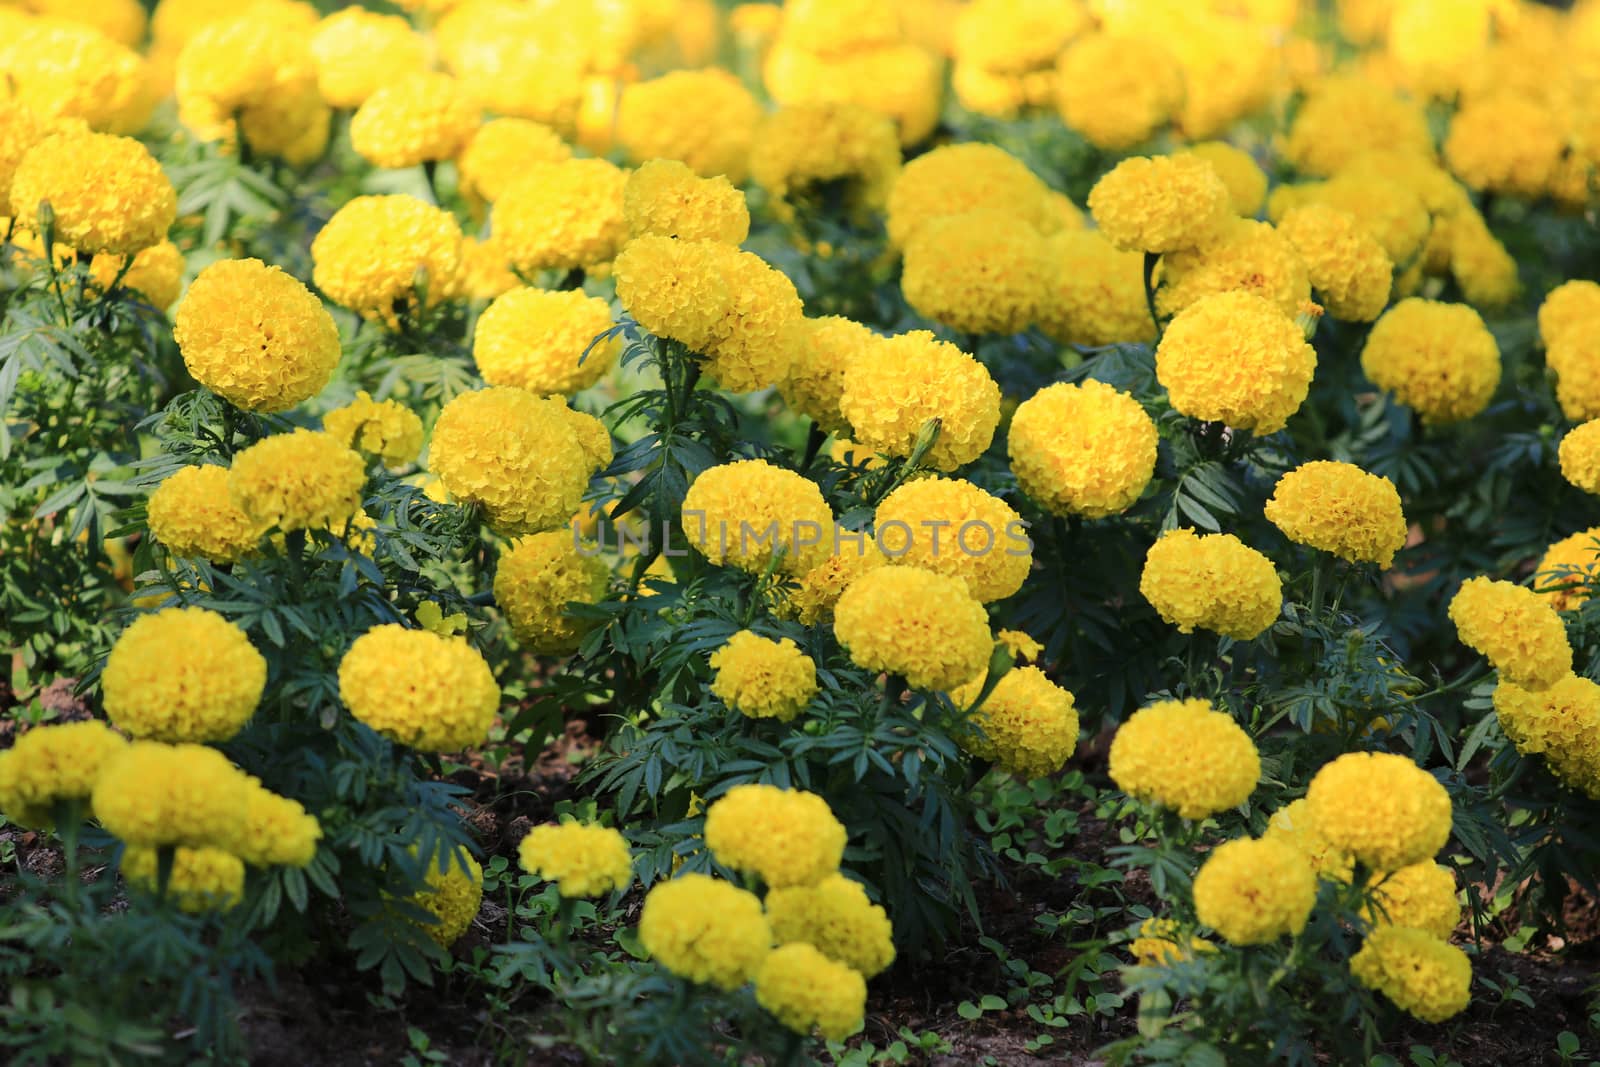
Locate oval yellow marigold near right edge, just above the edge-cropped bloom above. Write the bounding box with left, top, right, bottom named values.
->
left=1450, top=576, right=1573, bottom=691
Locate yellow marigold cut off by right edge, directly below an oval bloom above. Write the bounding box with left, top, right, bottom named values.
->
left=1494, top=675, right=1600, bottom=798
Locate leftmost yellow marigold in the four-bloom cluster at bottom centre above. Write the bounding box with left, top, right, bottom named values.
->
left=638, top=873, right=773, bottom=990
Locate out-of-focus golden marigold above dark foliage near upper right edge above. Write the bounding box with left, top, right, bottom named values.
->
left=1445, top=93, right=1566, bottom=200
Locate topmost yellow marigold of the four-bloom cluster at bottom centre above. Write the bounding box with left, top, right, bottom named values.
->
left=706, top=784, right=846, bottom=889
